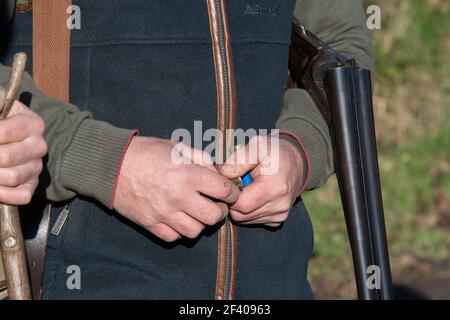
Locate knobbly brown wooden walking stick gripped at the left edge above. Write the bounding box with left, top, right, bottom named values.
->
left=0, top=53, right=31, bottom=300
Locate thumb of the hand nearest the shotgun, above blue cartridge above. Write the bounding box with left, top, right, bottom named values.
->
left=219, top=137, right=265, bottom=179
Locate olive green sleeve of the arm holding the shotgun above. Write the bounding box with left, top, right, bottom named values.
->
left=277, top=0, right=373, bottom=190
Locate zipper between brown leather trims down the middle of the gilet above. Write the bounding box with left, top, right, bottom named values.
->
left=216, top=0, right=232, bottom=300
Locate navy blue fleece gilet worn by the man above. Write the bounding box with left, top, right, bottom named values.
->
left=4, top=0, right=313, bottom=299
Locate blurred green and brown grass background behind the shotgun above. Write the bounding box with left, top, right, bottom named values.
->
left=303, top=0, right=450, bottom=299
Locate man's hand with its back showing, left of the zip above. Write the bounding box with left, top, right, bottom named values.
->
left=113, top=137, right=239, bottom=242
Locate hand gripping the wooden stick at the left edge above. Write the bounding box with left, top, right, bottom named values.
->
left=0, top=90, right=47, bottom=205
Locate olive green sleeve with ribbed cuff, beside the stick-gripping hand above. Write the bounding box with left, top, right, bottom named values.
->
left=0, top=64, right=134, bottom=207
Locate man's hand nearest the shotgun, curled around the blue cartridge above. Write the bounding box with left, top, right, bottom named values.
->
left=220, top=136, right=306, bottom=227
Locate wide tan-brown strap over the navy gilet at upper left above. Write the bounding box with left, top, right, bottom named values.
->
left=33, top=0, right=72, bottom=101
